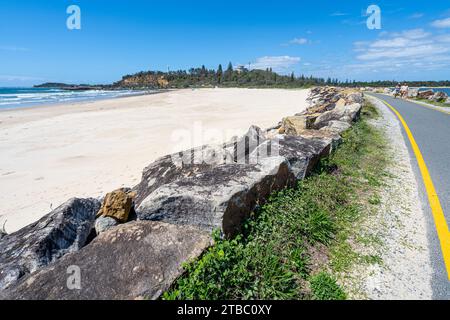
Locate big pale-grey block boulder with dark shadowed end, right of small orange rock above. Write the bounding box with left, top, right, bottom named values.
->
left=137, top=157, right=295, bottom=236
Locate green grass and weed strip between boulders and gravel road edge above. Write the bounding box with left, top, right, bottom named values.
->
left=163, top=100, right=386, bottom=300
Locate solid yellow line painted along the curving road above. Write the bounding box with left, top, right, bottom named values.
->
left=380, top=99, right=450, bottom=281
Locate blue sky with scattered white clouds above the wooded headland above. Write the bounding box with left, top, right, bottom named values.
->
left=0, top=0, right=450, bottom=86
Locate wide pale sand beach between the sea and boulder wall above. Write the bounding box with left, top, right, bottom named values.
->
left=0, top=89, right=308, bottom=232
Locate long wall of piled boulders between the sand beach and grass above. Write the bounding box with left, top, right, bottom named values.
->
left=0, top=87, right=363, bottom=299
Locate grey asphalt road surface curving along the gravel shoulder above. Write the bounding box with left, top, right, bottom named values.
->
left=371, top=94, right=450, bottom=300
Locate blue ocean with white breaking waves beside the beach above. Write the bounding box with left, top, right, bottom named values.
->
left=0, top=88, right=142, bottom=109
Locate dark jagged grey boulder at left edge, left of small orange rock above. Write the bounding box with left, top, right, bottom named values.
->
left=0, top=198, right=100, bottom=290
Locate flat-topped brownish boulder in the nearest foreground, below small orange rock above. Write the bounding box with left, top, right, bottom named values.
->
left=0, top=221, right=211, bottom=300
